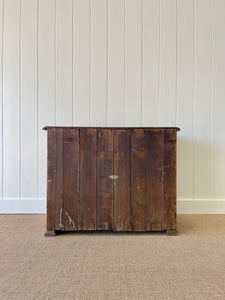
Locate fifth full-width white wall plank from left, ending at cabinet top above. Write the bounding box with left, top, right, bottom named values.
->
left=73, top=0, right=90, bottom=126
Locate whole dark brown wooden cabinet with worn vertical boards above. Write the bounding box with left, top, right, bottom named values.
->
left=43, top=127, right=179, bottom=236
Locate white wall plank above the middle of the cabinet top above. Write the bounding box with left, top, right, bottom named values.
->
left=108, top=0, right=125, bottom=126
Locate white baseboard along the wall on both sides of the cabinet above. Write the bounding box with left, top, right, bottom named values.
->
left=0, top=198, right=225, bottom=214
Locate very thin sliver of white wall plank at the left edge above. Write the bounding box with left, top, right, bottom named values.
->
left=0, top=0, right=4, bottom=200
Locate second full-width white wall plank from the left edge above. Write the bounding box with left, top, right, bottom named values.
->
left=20, top=0, right=37, bottom=199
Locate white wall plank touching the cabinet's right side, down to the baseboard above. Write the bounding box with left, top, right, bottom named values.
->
left=177, top=0, right=194, bottom=199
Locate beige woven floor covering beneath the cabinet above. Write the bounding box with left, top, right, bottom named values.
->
left=0, top=215, right=225, bottom=300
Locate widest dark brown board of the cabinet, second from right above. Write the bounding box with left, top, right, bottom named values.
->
left=131, top=129, right=164, bottom=231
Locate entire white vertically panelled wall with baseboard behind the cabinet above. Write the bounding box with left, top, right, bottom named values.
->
left=0, top=0, right=225, bottom=213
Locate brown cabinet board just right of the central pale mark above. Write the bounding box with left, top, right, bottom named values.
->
left=113, top=129, right=131, bottom=231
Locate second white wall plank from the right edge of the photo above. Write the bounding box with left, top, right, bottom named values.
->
left=193, top=0, right=212, bottom=199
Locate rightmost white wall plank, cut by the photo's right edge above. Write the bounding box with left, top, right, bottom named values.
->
left=211, top=0, right=225, bottom=200
